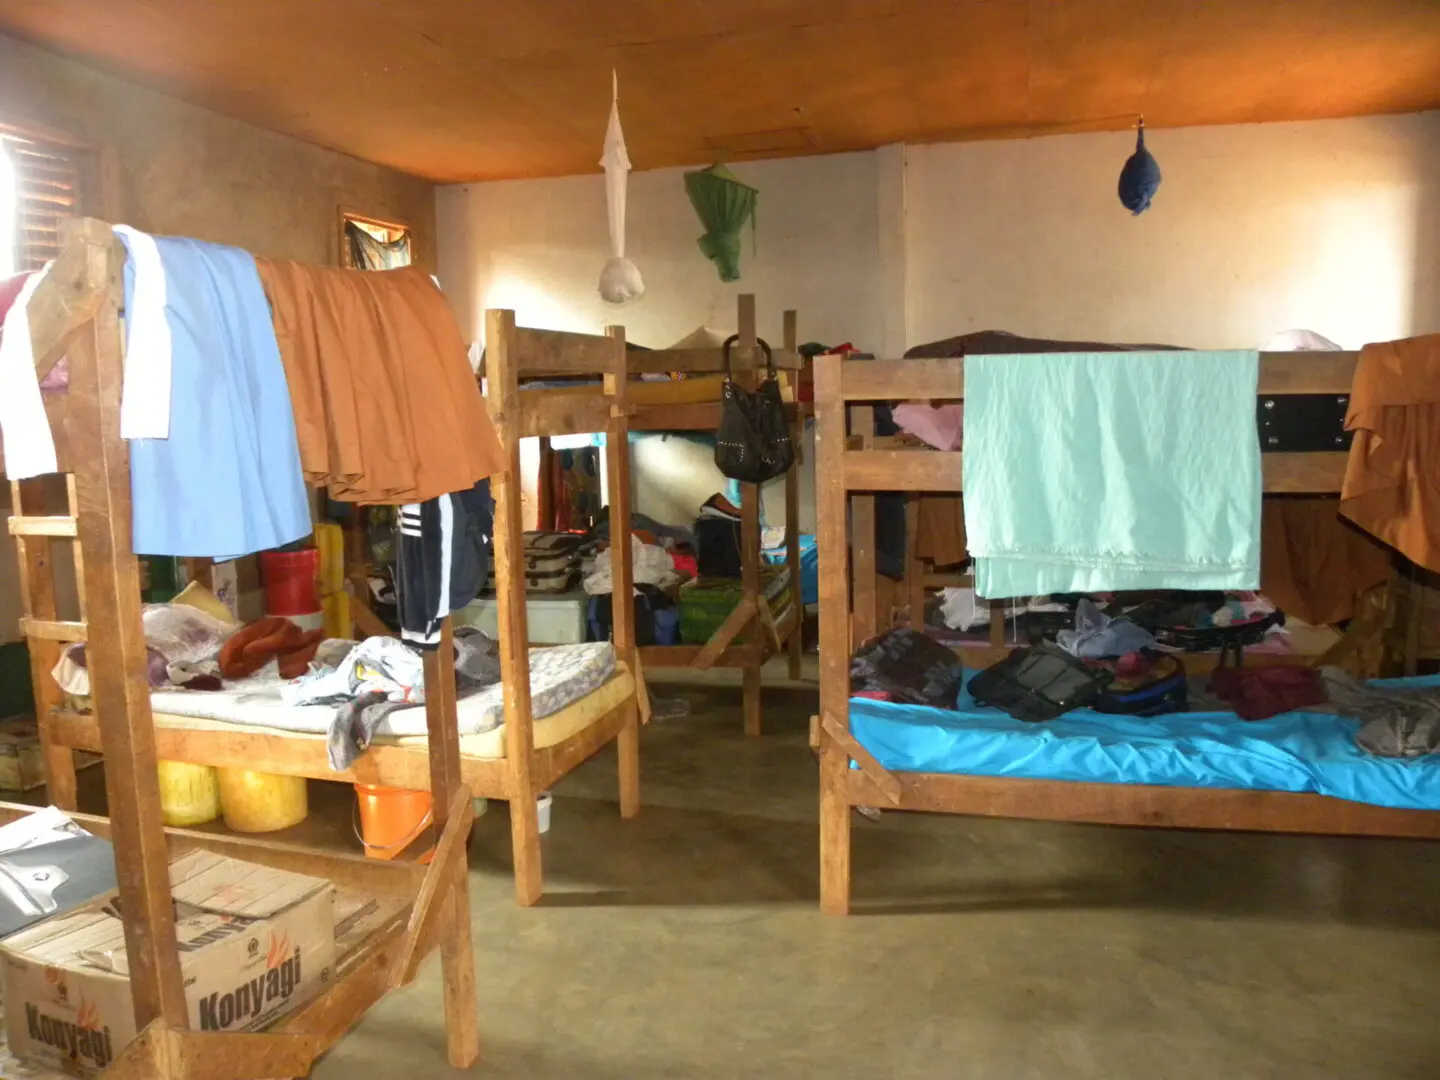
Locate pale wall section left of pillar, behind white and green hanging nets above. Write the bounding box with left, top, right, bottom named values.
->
left=436, top=154, right=875, bottom=530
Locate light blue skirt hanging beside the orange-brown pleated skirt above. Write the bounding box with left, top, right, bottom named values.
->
left=125, top=238, right=311, bottom=560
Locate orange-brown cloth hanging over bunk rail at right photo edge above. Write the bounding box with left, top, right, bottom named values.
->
left=1341, top=334, right=1440, bottom=570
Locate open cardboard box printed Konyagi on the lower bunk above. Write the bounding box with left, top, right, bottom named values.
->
left=0, top=851, right=336, bottom=1076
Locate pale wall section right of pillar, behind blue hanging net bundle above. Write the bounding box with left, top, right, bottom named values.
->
left=906, top=112, right=1440, bottom=348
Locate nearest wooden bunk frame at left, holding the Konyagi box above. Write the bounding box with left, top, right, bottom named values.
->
left=0, top=220, right=480, bottom=1080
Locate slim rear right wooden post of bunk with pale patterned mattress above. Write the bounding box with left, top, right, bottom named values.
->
left=605, top=327, right=644, bottom=818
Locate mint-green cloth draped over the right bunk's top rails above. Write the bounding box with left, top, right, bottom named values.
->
left=962, top=351, right=1261, bottom=599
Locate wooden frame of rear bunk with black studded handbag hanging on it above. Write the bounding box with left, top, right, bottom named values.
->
left=538, top=294, right=806, bottom=736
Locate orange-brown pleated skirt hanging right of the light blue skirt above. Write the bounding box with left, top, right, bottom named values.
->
left=255, top=259, right=504, bottom=504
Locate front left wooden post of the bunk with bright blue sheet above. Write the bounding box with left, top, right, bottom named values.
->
left=815, top=356, right=846, bottom=914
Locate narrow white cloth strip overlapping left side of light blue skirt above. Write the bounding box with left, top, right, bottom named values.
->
left=115, top=225, right=173, bottom=439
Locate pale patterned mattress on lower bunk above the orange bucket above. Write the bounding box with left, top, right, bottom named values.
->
left=150, top=642, right=634, bottom=756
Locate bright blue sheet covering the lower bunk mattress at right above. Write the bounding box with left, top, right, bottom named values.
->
left=850, top=675, right=1440, bottom=809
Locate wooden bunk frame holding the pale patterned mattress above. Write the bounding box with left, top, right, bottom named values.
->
left=26, top=247, right=645, bottom=906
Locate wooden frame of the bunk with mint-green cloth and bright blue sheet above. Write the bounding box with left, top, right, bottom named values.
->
left=812, top=353, right=1440, bottom=914
